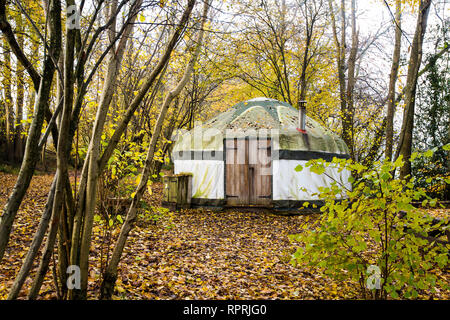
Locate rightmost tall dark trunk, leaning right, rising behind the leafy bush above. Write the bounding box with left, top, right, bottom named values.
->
left=396, top=0, right=431, bottom=178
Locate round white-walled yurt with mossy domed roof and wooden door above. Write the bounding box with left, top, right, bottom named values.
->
left=172, top=98, right=350, bottom=209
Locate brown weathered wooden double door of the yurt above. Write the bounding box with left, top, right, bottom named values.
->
left=225, top=139, right=272, bottom=206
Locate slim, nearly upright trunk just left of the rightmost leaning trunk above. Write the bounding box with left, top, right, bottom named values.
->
left=384, top=0, right=402, bottom=160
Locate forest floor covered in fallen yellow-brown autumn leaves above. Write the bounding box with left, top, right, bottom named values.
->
left=0, top=172, right=450, bottom=299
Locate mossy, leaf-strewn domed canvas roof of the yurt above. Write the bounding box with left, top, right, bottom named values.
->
left=174, top=98, right=348, bottom=154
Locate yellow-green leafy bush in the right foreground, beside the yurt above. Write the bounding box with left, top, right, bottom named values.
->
left=291, top=146, right=449, bottom=299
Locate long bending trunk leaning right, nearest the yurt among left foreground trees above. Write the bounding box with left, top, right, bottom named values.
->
left=101, top=1, right=209, bottom=299
